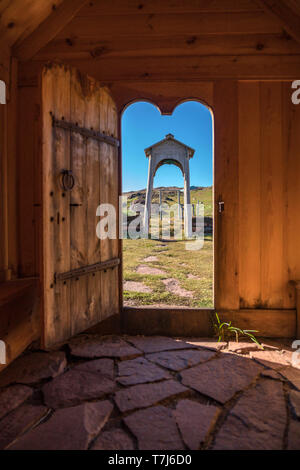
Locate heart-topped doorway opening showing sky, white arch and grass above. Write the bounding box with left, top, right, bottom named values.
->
left=122, top=101, right=214, bottom=308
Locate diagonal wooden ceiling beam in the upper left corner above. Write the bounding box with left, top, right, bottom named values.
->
left=12, top=0, right=88, bottom=61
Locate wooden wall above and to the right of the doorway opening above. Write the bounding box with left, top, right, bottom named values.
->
left=15, top=63, right=300, bottom=316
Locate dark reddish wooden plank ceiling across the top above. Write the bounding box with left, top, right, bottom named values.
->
left=0, top=0, right=300, bottom=81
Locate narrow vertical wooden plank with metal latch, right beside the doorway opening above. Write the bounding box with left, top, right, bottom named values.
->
left=214, top=81, right=239, bottom=309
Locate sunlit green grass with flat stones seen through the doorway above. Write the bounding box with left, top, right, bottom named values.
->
left=123, top=188, right=213, bottom=307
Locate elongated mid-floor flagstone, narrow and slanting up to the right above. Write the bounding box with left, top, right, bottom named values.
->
left=115, top=380, right=189, bottom=413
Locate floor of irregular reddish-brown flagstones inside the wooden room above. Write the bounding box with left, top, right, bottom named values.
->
left=0, top=335, right=300, bottom=450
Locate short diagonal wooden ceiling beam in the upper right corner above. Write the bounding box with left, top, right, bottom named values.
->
left=258, top=0, right=300, bottom=43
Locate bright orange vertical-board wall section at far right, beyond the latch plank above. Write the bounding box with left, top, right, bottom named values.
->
left=238, top=82, right=300, bottom=308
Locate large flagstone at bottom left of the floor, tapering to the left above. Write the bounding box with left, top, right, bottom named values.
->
left=10, top=400, right=113, bottom=450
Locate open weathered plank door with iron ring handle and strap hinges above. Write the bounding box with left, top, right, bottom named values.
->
left=41, top=64, right=119, bottom=347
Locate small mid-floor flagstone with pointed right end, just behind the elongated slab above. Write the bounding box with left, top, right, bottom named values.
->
left=117, top=357, right=172, bottom=385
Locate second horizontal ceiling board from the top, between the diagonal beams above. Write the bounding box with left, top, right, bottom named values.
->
left=57, top=12, right=282, bottom=38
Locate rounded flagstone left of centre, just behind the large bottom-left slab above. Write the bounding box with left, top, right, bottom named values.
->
left=42, top=370, right=115, bottom=408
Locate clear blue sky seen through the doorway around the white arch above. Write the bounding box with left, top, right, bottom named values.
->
left=122, top=101, right=213, bottom=192
